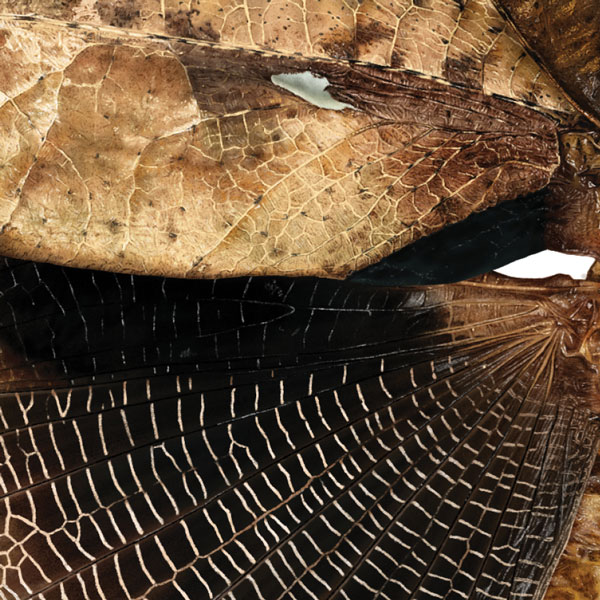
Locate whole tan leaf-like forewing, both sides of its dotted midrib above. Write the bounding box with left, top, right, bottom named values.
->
left=0, top=0, right=564, bottom=277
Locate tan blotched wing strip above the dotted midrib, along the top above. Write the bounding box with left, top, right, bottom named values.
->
left=0, top=0, right=572, bottom=113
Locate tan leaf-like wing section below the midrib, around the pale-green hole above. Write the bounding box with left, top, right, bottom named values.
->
left=0, top=21, right=558, bottom=277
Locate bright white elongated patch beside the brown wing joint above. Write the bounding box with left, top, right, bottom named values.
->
left=496, top=250, right=594, bottom=279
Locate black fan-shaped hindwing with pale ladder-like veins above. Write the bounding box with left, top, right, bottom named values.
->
left=0, top=262, right=598, bottom=600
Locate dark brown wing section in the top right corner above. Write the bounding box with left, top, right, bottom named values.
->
left=495, top=0, right=600, bottom=127
